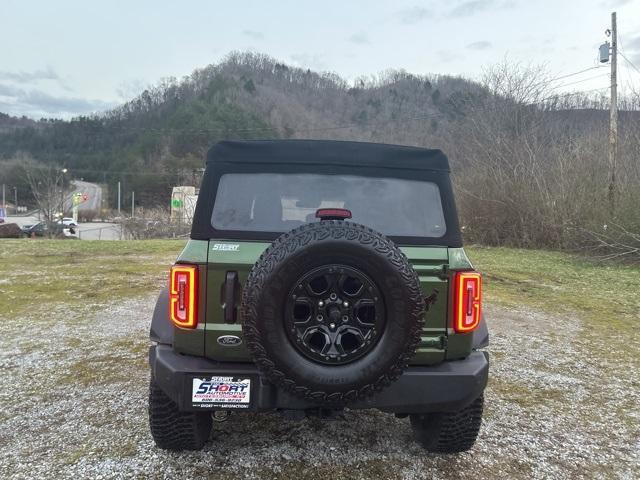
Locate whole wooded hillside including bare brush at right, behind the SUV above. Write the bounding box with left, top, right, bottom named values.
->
left=0, top=53, right=640, bottom=255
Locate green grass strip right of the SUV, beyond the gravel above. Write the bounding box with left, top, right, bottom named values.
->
left=466, top=247, right=640, bottom=330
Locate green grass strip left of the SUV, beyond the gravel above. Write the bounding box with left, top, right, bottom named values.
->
left=0, top=239, right=185, bottom=317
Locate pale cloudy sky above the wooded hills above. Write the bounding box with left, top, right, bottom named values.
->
left=0, top=0, right=640, bottom=118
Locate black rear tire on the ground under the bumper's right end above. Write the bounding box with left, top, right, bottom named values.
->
left=410, top=395, right=484, bottom=453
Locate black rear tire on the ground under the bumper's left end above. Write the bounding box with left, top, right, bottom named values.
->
left=149, top=378, right=212, bottom=450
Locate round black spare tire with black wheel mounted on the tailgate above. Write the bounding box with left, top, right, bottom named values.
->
left=241, top=220, right=425, bottom=404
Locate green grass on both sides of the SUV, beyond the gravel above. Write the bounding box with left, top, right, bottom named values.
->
left=0, top=240, right=640, bottom=330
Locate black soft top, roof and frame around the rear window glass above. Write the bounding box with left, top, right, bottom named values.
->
left=191, top=140, right=462, bottom=247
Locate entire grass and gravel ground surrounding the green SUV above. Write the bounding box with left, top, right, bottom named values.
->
left=0, top=239, right=640, bottom=479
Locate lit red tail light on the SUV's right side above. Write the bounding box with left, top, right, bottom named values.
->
left=453, top=272, right=482, bottom=333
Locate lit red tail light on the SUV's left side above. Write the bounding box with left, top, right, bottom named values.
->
left=169, top=265, right=198, bottom=328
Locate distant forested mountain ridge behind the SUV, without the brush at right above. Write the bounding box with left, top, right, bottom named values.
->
left=0, top=54, right=480, bottom=204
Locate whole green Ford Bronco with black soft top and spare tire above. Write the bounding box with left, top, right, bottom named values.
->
left=149, top=140, right=489, bottom=452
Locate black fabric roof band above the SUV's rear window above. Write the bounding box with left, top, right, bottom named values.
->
left=207, top=140, right=449, bottom=172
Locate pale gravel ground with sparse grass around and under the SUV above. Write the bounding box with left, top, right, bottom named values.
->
left=0, top=298, right=640, bottom=479
